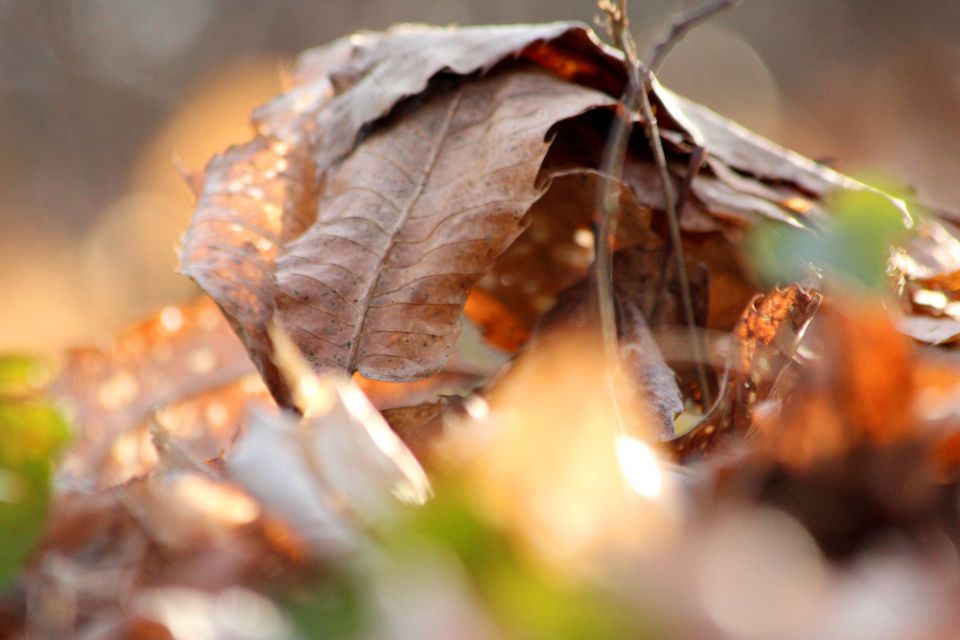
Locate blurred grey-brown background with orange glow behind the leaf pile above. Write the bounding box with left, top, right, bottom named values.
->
left=0, top=0, right=960, bottom=353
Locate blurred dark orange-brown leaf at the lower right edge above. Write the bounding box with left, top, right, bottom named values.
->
left=704, top=301, right=960, bottom=557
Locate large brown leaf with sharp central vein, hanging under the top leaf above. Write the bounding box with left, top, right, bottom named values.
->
left=276, top=69, right=610, bottom=381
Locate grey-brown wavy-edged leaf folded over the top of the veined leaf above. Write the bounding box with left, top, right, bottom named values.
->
left=255, top=22, right=619, bottom=170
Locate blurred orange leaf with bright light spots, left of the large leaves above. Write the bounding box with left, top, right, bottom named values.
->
left=50, top=298, right=260, bottom=486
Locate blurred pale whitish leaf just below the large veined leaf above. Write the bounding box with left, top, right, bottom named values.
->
left=227, top=330, right=430, bottom=556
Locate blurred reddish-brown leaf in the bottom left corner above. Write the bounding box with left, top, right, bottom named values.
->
left=24, top=473, right=306, bottom=638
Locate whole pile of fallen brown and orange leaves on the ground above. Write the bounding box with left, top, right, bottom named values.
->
left=9, top=18, right=960, bottom=640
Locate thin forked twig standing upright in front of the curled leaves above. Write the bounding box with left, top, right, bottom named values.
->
left=595, top=0, right=739, bottom=416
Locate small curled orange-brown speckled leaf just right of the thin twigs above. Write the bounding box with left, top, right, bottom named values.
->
left=670, top=285, right=820, bottom=461
